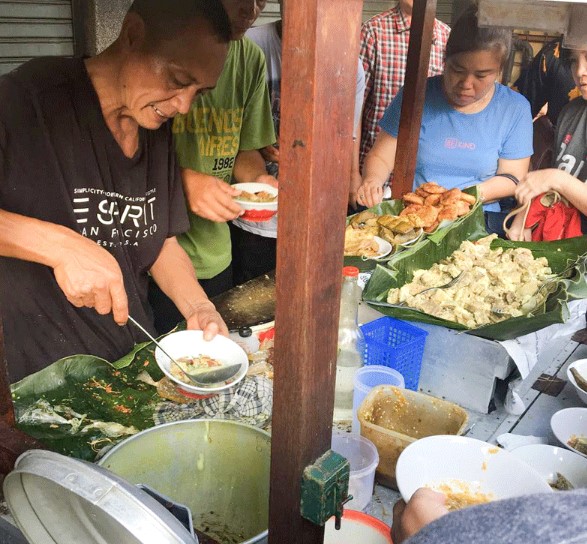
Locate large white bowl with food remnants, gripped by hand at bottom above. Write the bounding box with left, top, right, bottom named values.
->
left=395, top=435, right=552, bottom=501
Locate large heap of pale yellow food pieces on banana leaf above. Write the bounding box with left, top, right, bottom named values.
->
left=387, top=235, right=551, bottom=328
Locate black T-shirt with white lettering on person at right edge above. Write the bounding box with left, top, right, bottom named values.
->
left=554, top=97, right=587, bottom=234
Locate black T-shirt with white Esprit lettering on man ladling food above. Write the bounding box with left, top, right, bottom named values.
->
left=0, top=58, right=189, bottom=381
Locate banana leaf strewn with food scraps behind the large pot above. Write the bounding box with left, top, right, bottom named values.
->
left=11, top=342, right=163, bottom=461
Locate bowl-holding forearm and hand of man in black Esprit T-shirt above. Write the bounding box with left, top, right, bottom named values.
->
left=150, top=238, right=228, bottom=340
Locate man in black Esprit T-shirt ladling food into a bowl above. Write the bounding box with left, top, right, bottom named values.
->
left=0, top=0, right=230, bottom=381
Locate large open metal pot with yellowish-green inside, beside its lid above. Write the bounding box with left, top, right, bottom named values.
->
left=99, top=420, right=271, bottom=544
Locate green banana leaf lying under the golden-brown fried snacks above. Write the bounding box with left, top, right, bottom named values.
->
left=344, top=187, right=487, bottom=272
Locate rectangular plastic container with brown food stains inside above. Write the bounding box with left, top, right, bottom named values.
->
left=358, top=385, right=469, bottom=489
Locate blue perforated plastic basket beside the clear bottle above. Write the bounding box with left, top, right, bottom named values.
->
left=361, top=317, right=428, bottom=391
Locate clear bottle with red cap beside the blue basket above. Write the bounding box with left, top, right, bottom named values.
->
left=334, top=266, right=365, bottom=421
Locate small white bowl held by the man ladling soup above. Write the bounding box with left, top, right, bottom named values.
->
left=155, top=330, right=249, bottom=395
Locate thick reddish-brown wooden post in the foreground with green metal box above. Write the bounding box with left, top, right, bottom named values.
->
left=269, top=0, right=362, bottom=544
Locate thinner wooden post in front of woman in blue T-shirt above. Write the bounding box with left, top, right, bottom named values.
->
left=391, top=0, right=436, bottom=198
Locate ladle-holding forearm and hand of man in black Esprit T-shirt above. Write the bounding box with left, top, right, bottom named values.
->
left=0, top=210, right=128, bottom=325
